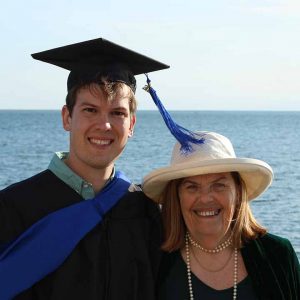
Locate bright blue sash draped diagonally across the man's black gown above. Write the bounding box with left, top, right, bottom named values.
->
left=0, top=172, right=130, bottom=300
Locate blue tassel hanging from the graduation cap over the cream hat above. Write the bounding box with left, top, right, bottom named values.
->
left=144, top=74, right=204, bottom=154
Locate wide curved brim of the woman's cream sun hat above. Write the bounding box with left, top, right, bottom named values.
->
left=142, top=158, right=273, bottom=202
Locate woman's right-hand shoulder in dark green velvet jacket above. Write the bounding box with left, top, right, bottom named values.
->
left=241, top=233, right=300, bottom=299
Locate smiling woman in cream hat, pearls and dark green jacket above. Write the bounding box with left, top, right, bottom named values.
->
left=143, top=132, right=300, bottom=300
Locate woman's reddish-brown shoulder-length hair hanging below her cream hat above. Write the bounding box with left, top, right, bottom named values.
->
left=159, top=172, right=266, bottom=252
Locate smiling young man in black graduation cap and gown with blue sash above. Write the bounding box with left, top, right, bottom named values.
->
left=0, top=39, right=168, bottom=300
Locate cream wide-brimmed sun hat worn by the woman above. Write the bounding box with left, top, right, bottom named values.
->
left=142, top=131, right=273, bottom=202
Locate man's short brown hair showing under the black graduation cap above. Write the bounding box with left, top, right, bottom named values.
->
left=66, top=77, right=137, bottom=116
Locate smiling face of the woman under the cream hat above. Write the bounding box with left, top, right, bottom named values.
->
left=178, top=173, right=237, bottom=242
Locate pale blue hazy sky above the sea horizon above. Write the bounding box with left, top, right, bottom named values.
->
left=0, top=0, right=300, bottom=111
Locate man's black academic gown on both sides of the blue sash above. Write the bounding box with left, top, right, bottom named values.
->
left=0, top=170, right=161, bottom=300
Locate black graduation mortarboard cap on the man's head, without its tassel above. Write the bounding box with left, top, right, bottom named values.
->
left=32, top=38, right=169, bottom=92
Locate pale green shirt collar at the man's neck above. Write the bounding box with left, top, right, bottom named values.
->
left=48, top=152, right=115, bottom=200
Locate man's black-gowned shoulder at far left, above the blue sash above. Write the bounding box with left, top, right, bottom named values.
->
left=0, top=170, right=82, bottom=241
